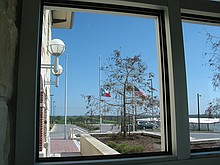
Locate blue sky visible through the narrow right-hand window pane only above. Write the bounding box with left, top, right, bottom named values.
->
left=183, top=23, right=220, bottom=114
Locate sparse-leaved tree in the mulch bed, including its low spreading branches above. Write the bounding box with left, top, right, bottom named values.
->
left=82, top=50, right=159, bottom=136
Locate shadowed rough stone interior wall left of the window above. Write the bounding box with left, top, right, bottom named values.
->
left=0, top=0, right=18, bottom=165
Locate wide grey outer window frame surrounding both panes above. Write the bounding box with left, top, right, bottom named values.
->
left=15, top=0, right=220, bottom=165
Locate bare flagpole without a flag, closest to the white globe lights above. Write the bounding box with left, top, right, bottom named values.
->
left=64, top=54, right=68, bottom=139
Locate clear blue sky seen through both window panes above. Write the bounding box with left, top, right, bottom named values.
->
left=47, top=9, right=220, bottom=116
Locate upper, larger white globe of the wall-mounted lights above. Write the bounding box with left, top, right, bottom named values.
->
left=48, top=39, right=65, bottom=56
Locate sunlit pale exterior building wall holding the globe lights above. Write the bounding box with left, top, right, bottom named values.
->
left=39, top=10, right=53, bottom=157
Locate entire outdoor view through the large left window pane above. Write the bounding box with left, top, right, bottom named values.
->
left=39, top=6, right=168, bottom=157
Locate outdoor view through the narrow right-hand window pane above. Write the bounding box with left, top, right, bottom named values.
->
left=183, top=19, right=220, bottom=151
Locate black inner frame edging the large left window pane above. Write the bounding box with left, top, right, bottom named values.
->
left=35, top=0, right=172, bottom=162
